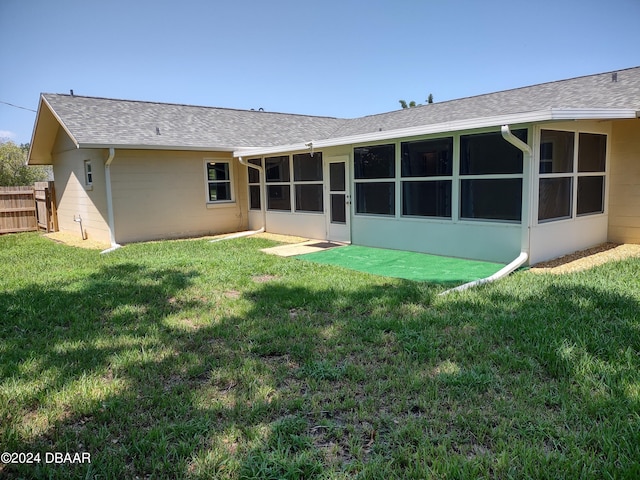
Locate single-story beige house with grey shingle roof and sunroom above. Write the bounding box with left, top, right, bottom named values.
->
left=29, top=67, right=640, bottom=263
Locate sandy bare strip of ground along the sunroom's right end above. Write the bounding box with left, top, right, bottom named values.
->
left=530, top=243, right=640, bottom=274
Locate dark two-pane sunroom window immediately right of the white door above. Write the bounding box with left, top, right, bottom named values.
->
left=353, top=145, right=396, bottom=215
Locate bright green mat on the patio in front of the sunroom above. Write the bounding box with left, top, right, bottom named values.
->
left=296, top=245, right=504, bottom=283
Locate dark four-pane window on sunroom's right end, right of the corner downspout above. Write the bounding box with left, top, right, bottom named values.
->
left=538, top=130, right=607, bottom=222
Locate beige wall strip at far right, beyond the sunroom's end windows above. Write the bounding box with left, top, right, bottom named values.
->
left=609, top=120, right=640, bottom=243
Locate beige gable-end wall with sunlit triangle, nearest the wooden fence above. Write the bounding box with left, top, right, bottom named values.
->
left=52, top=129, right=109, bottom=243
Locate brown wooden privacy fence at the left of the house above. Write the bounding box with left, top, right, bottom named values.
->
left=0, top=182, right=58, bottom=234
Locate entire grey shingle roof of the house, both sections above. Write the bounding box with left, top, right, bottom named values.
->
left=38, top=63, right=640, bottom=150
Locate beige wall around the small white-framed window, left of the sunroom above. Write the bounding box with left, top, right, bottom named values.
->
left=111, top=150, right=248, bottom=243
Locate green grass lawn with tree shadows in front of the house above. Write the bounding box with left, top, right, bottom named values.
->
left=0, top=234, right=640, bottom=479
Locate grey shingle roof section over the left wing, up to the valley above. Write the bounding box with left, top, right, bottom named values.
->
left=43, top=94, right=345, bottom=150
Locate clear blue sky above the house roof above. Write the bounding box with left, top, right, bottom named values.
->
left=0, top=0, right=640, bottom=143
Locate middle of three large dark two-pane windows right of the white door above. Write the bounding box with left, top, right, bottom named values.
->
left=400, top=137, right=453, bottom=218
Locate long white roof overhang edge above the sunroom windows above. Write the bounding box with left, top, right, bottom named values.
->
left=233, top=108, right=639, bottom=157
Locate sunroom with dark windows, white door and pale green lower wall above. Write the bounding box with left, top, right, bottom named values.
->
left=241, top=118, right=610, bottom=263
